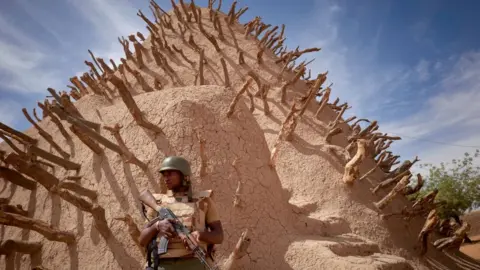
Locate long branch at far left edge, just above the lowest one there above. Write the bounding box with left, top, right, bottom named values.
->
left=0, top=212, right=75, bottom=244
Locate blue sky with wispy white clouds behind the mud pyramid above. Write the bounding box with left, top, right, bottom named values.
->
left=0, top=0, right=480, bottom=170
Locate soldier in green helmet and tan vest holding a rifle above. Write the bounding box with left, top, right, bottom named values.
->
left=139, top=156, right=223, bottom=270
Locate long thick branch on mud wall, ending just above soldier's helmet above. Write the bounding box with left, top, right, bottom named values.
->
left=110, top=76, right=163, bottom=133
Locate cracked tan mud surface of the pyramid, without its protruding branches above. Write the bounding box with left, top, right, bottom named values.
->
left=0, top=2, right=480, bottom=269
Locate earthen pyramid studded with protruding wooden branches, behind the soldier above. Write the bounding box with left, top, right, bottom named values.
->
left=0, top=0, right=478, bottom=269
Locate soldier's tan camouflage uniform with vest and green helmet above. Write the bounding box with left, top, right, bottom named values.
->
left=141, top=157, right=219, bottom=270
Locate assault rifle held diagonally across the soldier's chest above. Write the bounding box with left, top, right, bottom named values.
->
left=140, top=190, right=217, bottom=270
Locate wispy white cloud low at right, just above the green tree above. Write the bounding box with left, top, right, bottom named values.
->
left=382, top=52, right=480, bottom=170
